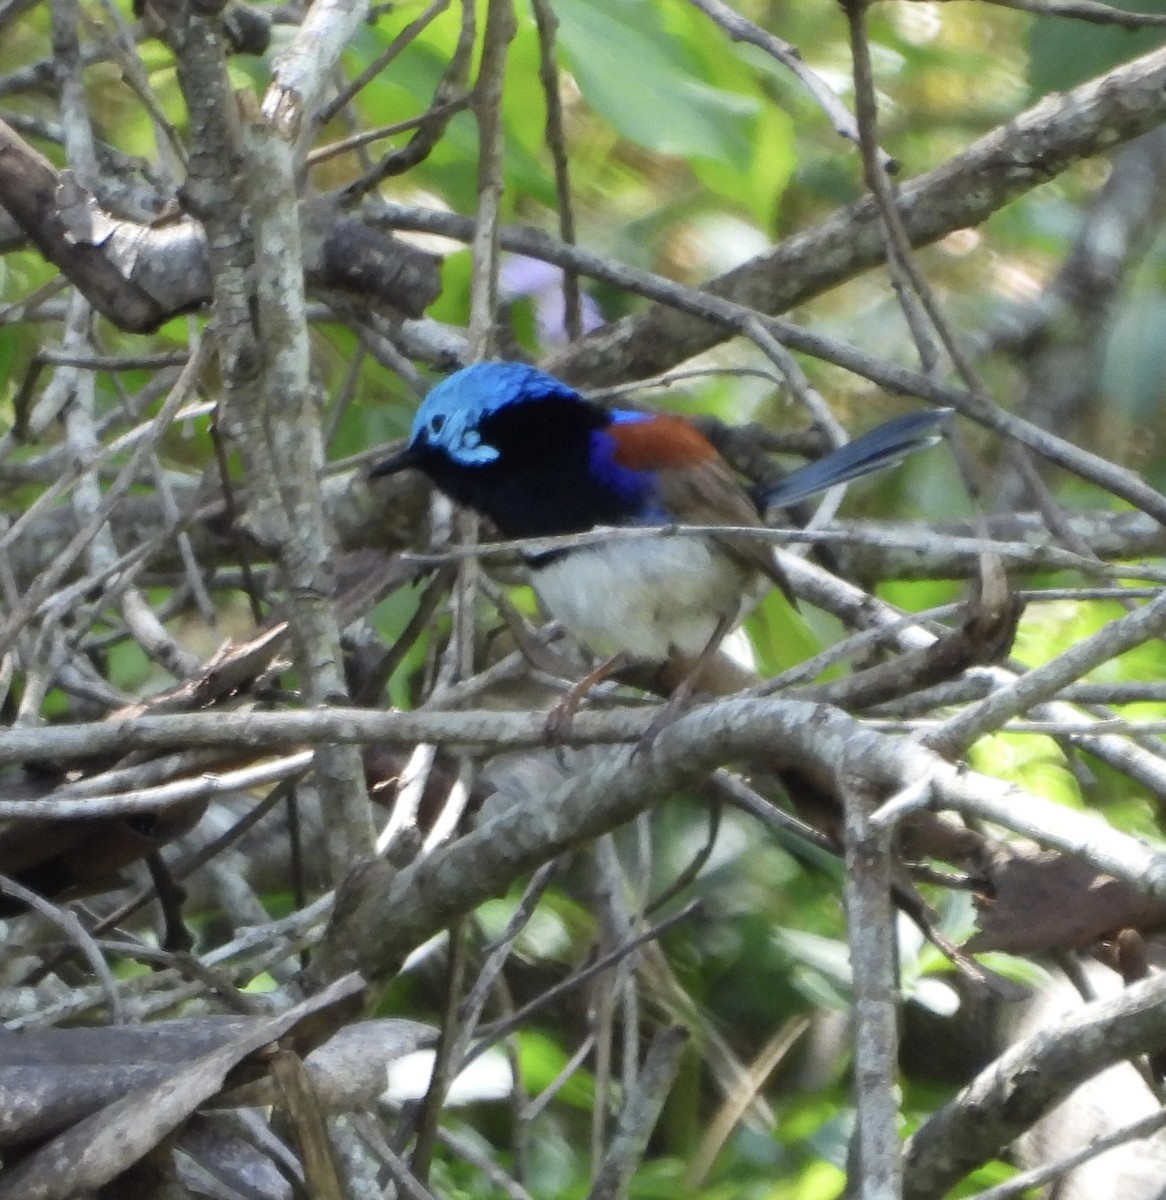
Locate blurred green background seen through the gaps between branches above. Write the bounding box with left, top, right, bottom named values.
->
left=0, top=0, right=1166, bottom=1200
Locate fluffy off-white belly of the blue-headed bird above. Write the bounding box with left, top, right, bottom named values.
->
left=531, top=533, right=756, bottom=662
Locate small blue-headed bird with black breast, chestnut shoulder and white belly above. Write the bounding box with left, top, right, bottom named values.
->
left=369, top=361, right=951, bottom=709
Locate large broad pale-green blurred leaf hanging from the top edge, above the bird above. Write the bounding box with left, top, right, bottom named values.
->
left=555, top=0, right=758, bottom=170
